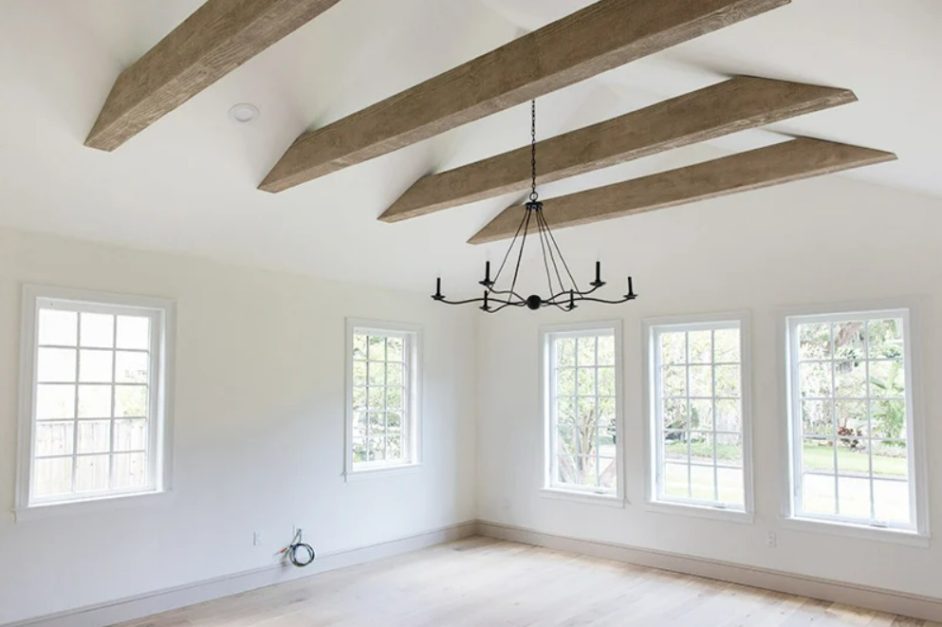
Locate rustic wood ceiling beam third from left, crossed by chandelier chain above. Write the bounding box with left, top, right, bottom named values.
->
left=379, top=76, right=857, bottom=222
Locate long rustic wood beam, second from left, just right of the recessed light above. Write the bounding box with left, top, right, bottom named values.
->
left=259, top=0, right=790, bottom=192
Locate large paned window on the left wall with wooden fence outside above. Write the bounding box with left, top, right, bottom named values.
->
left=18, top=287, right=169, bottom=509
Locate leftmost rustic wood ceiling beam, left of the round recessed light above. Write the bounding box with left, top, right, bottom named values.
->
left=85, top=0, right=339, bottom=151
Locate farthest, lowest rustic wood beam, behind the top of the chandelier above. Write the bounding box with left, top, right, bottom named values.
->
left=468, top=137, right=896, bottom=244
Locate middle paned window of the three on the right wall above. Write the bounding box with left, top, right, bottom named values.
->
left=648, top=319, right=750, bottom=511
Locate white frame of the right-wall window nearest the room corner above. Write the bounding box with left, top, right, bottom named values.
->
left=539, top=320, right=626, bottom=507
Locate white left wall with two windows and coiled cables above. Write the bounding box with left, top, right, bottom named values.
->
left=0, top=230, right=475, bottom=623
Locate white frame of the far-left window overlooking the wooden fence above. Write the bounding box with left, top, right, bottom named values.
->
left=14, top=284, right=175, bottom=520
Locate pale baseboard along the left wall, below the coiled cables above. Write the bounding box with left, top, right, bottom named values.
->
left=7, top=521, right=476, bottom=627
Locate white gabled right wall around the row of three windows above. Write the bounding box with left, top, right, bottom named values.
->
left=477, top=177, right=942, bottom=598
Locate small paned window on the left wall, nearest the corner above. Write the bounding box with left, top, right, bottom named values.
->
left=347, top=323, right=419, bottom=472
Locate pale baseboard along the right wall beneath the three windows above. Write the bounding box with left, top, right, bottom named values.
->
left=477, top=521, right=942, bottom=621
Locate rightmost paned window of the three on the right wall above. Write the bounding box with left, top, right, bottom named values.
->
left=788, top=310, right=918, bottom=531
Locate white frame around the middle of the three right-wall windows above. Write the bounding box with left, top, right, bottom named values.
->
left=642, top=312, right=755, bottom=523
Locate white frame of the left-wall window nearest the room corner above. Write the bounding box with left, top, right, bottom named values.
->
left=343, top=318, right=423, bottom=481
